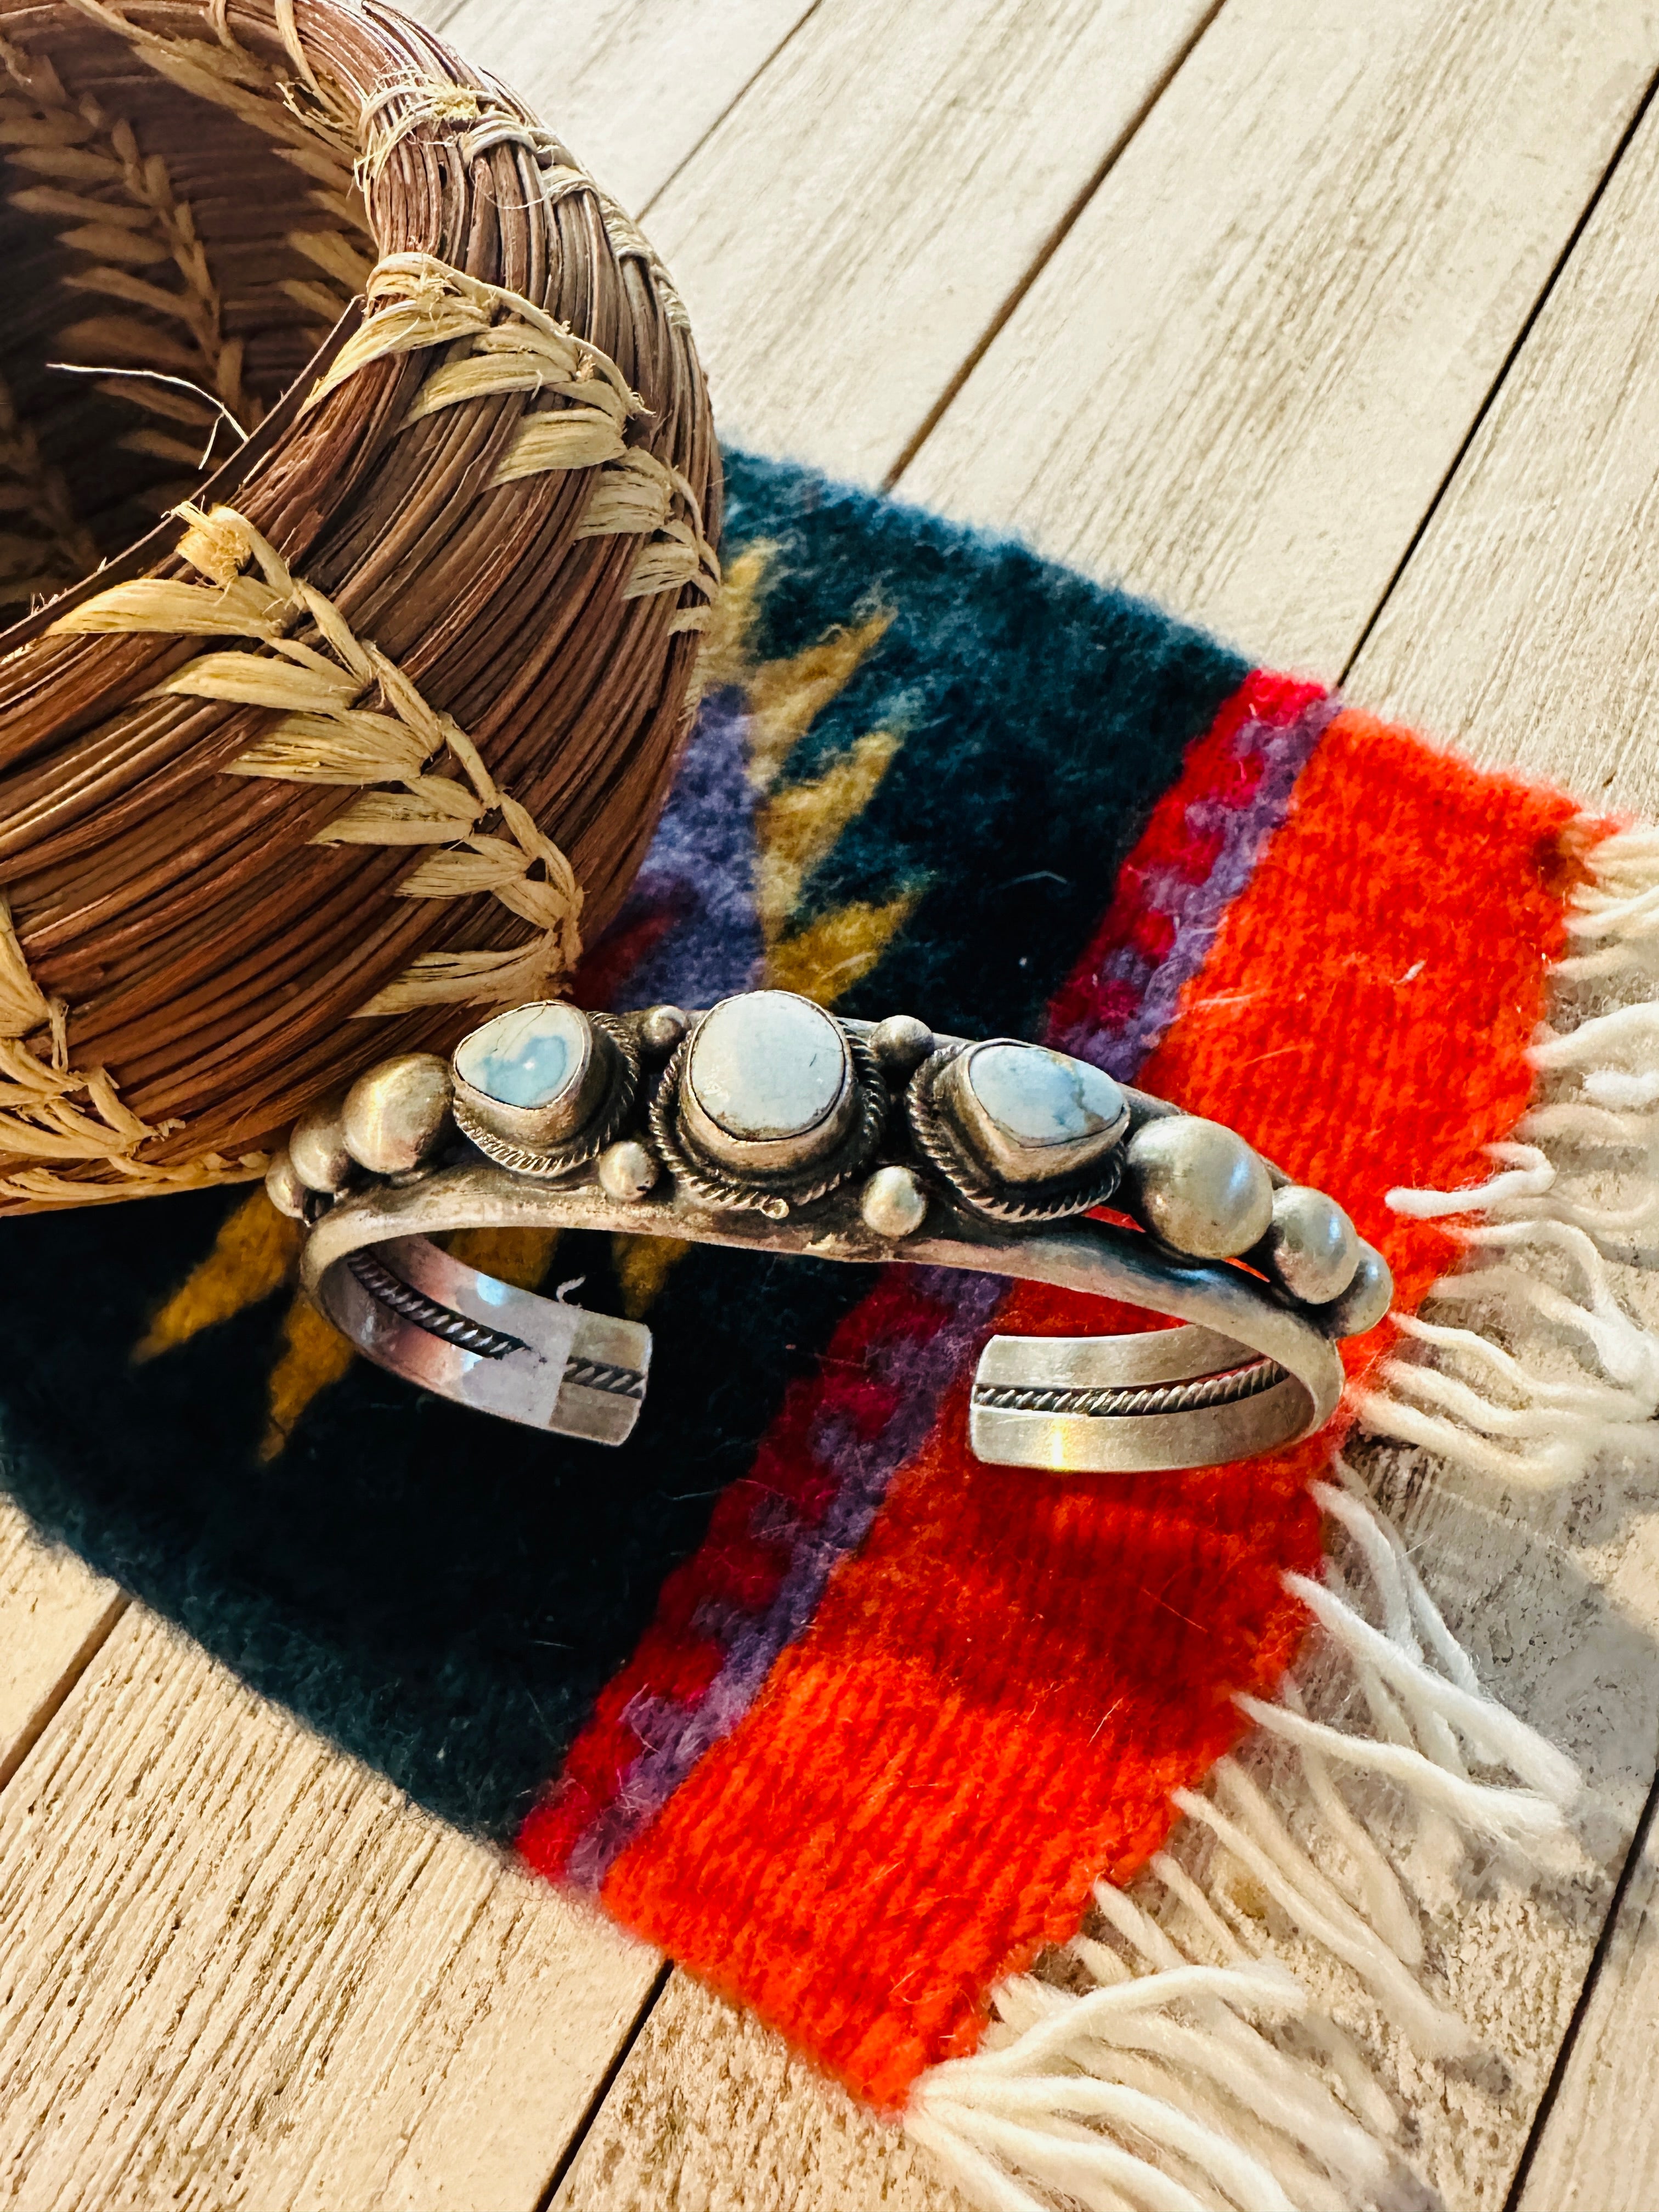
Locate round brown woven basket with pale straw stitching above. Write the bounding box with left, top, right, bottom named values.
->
left=0, top=0, right=719, bottom=1212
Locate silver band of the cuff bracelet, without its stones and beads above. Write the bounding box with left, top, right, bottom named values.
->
left=303, top=1166, right=1342, bottom=1473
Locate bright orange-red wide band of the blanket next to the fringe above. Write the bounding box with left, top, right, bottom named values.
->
left=604, top=712, right=1573, bottom=2103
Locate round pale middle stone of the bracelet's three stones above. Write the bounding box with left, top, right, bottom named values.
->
left=686, top=991, right=847, bottom=1144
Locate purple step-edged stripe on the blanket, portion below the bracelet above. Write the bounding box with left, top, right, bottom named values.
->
left=566, top=1267, right=1009, bottom=1889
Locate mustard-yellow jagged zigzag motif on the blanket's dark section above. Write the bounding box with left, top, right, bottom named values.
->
left=133, top=544, right=916, bottom=1460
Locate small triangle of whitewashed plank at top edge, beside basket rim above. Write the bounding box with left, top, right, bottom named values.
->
left=425, top=0, right=812, bottom=215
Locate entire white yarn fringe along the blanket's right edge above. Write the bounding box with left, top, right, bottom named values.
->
left=905, top=830, right=1659, bottom=2212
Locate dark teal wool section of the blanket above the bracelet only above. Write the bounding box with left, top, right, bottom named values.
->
left=725, top=452, right=1250, bottom=1037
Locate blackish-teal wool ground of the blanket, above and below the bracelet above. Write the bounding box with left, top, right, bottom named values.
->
left=0, top=454, right=1245, bottom=1838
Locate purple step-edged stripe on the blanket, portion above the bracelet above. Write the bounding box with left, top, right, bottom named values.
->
left=1051, top=697, right=1340, bottom=1082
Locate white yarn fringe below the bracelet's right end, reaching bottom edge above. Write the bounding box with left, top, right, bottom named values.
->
left=905, top=1460, right=1579, bottom=2212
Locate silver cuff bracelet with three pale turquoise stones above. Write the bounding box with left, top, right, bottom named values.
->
left=268, top=991, right=1391, bottom=1473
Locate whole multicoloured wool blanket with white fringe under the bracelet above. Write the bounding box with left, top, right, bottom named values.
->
left=0, top=454, right=1659, bottom=2212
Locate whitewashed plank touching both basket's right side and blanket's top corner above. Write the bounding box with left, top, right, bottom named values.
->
left=650, top=0, right=1215, bottom=482
